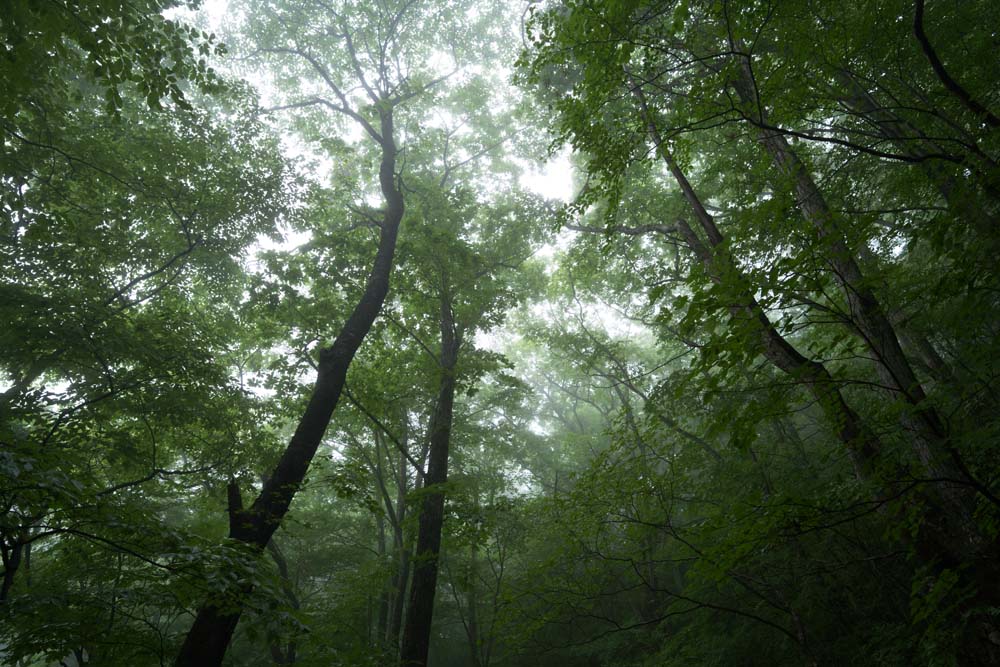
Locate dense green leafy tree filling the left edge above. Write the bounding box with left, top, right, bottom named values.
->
left=0, top=3, right=291, bottom=661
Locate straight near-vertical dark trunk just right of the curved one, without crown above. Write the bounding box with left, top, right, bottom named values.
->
left=400, top=288, right=461, bottom=667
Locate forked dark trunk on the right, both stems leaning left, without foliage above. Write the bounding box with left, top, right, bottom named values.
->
left=629, top=49, right=1000, bottom=665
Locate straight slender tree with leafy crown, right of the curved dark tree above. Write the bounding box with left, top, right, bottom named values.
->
left=400, top=184, right=539, bottom=665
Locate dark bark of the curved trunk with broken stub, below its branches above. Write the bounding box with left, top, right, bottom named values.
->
left=176, top=106, right=404, bottom=667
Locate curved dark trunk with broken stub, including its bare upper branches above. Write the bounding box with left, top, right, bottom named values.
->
left=176, top=0, right=419, bottom=665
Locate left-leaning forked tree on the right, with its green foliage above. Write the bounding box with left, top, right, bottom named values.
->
left=524, top=3, right=995, bottom=664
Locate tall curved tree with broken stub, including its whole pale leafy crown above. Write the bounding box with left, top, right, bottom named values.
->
left=178, top=2, right=532, bottom=664
